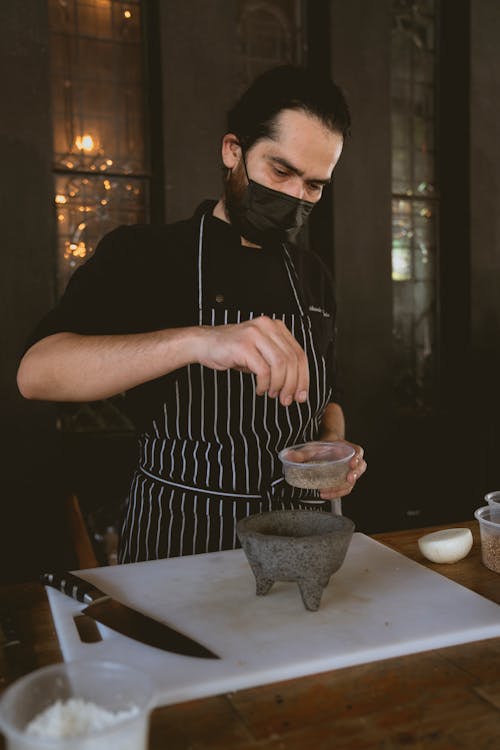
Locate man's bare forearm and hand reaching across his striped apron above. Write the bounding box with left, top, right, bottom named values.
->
left=17, top=316, right=309, bottom=406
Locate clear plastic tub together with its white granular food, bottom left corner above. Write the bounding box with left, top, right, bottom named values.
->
left=0, top=659, right=155, bottom=750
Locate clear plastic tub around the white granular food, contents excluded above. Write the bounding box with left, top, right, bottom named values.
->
left=0, top=661, right=154, bottom=750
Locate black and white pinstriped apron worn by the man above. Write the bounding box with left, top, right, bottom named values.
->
left=119, top=216, right=331, bottom=563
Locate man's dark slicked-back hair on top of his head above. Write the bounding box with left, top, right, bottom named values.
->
left=227, top=65, right=351, bottom=149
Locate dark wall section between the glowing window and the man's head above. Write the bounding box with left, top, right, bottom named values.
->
left=160, top=0, right=241, bottom=221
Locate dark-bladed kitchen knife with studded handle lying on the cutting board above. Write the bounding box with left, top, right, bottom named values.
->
left=40, top=573, right=219, bottom=659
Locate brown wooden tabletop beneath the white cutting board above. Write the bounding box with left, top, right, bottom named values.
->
left=0, top=521, right=500, bottom=750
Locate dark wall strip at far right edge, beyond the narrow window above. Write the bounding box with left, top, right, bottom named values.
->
left=468, top=0, right=500, bottom=498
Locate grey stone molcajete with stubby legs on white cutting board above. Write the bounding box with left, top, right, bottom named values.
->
left=236, top=510, right=354, bottom=611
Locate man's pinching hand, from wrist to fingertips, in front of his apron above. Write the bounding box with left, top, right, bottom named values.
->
left=197, top=315, right=309, bottom=406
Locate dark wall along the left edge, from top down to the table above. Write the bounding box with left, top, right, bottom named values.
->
left=0, top=0, right=74, bottom=577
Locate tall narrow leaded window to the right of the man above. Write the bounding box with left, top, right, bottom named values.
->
left=391, top=0, right=439, bottom=413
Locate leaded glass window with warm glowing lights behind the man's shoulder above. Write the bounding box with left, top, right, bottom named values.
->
left=49, top=0, right=149, bottom=293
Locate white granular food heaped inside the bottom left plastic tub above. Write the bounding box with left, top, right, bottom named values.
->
left=26, top=698, right=139, bottom=739
